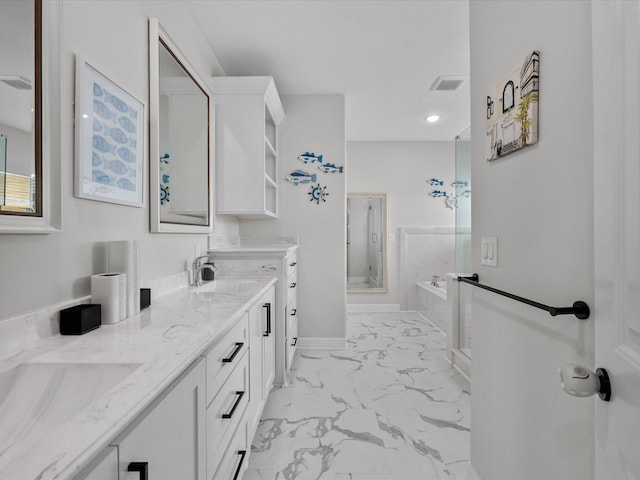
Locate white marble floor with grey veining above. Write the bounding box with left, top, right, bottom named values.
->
left=244, top=312, right=471, bottom=480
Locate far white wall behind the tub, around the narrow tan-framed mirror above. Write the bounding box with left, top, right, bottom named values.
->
left=347, top=139, right=455, bottom=304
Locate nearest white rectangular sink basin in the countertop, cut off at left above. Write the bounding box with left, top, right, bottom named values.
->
left=0, top=363, right=141, bottom=452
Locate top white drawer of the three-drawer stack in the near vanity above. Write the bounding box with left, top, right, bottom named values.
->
left=207, top=314, right=249, bottom=405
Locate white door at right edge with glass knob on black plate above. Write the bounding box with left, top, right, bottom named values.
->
left=585, top=0, right=640, bottom=480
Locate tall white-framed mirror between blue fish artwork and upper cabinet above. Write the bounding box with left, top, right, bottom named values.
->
left=149, top=19, right=213, bottom=233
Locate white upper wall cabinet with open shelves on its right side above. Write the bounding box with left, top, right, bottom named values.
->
left=209, top=77, right=284, bottom=218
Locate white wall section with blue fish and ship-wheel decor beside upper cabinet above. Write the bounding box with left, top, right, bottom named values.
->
left=240, top=95, right=348, bottom=338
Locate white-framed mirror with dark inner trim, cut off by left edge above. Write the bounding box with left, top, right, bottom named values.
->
left=0, top=0, right=61, bottom=233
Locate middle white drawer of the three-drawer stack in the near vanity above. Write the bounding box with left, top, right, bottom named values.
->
left=207, top=354, right=249, bottom=478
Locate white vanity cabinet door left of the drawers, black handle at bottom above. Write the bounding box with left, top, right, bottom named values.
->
left=114, top=359, right=206, bottom=480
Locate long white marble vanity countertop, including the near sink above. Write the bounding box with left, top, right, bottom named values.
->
left=0, top=278, right=275, bottom=480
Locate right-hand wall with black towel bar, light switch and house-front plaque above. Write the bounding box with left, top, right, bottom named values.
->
left=470, top=0, right=597, bottom=480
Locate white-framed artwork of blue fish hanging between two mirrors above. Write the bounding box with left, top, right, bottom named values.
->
left=74, top=55, right=146, bottom=207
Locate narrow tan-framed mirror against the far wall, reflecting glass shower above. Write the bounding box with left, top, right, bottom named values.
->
left=347, top=193, right=387, bottom=293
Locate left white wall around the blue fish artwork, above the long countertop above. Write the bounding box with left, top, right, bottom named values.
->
left=0, top=0, right=239, bottom=320
